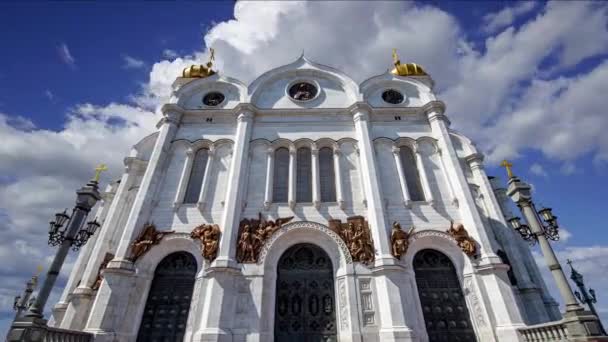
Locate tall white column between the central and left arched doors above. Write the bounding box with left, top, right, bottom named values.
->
left=193, top=107, right=254, bottom=342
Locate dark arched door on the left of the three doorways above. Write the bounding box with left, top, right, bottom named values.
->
left=137, top=252, right=197, bottom=342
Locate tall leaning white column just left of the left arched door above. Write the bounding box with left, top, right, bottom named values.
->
left=85, top=105, right=183, bottom=342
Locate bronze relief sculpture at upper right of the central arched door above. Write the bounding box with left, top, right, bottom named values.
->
left=329, top=216, right=374, bottom=265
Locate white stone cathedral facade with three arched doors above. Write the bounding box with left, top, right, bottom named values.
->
left=53, top=56, right=560, bottom=342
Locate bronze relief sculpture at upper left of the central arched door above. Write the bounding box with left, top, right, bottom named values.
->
left=236, top=213, right=293, bottom=264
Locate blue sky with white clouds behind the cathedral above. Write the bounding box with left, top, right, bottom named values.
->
left=0, top=1, right=608, bottom=332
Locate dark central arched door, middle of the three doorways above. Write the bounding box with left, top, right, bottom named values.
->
left=274, top=244, right=337, bottom=342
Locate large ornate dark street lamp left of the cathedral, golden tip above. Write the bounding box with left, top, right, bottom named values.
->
left=7, top=164, right=107, bottom=341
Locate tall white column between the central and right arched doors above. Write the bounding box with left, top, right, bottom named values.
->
left=352, top=104, right=413, bottom=342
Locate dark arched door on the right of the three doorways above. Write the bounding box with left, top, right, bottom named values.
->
left=414, top=249, right=477, bottom=342
